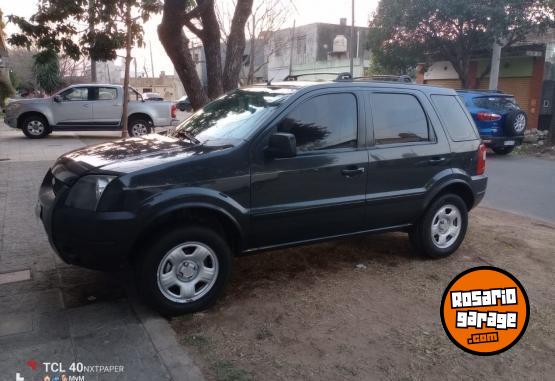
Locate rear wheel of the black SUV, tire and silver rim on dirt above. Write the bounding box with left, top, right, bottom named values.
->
left=409, top=193, right=468, bottom=258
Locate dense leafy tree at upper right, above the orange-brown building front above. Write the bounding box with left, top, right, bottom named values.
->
left=369, top=0, right=553, bottom=88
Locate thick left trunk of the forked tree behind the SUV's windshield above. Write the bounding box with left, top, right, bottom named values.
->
left=158, top=0, right=208, bottom=110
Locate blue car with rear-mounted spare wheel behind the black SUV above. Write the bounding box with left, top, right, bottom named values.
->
left=457, top=90, right=527, bottom=155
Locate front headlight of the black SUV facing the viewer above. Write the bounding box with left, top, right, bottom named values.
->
left=66, top=175, right=116, bottom=210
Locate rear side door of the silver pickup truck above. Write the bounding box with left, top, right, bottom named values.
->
left=92, top=86, right=123, bottom=129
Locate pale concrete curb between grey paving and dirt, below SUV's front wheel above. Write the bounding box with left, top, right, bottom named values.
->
left=126, top=281, right=204, bottom=381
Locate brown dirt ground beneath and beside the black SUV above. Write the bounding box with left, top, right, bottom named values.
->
left=172, top=208, right=555, bottom=381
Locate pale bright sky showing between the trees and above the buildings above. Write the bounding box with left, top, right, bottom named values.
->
left=0, top=0, right=378, bottom=75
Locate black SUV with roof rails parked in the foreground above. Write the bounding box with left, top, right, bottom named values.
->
left=37, top=80, right=487, bottom=314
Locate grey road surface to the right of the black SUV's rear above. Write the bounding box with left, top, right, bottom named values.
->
left=483, top=154, right=555, bottom=222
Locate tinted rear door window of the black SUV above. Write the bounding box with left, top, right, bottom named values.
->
left=372, top=93, right=432, bottom=145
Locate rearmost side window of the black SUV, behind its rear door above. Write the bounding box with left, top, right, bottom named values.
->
left=432, top=95, right=478, bottom=142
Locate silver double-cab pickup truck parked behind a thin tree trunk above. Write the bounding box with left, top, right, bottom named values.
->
left=4, top=84, right=176, bottom=139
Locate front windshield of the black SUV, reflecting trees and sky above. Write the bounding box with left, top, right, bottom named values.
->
left=172, top=87, right=296, bottom=143
